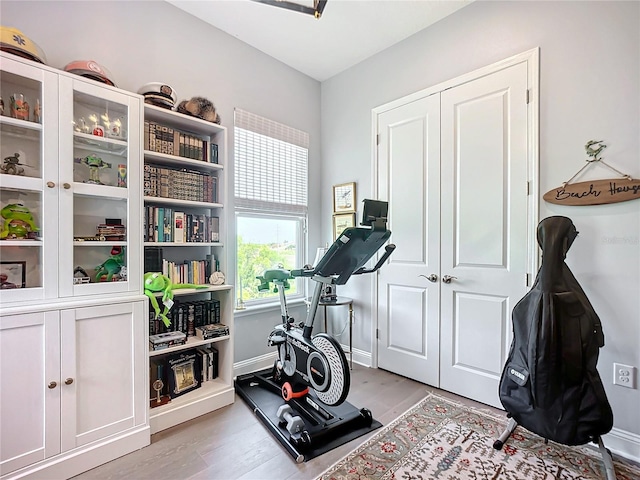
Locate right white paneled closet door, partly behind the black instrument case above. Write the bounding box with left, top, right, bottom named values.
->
left=440, top=63, right=528, bottom=406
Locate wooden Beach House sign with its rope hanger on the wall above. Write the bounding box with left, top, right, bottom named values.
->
left=542, top=140, right=640, bottom=206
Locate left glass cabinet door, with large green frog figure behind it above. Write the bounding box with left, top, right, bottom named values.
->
left=0, top=56, right=58, bottom=305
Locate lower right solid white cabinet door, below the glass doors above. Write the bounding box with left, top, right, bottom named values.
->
left=61, top=303, right=142, bottom=450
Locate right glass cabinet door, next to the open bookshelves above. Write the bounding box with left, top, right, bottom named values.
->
left=59, top=77, right=142, bottom=296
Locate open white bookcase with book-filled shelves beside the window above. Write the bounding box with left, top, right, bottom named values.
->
left=143, top=104, right=234, bottom=433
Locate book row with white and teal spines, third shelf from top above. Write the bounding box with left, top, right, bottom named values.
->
left=143, top=205, right=220, bottom=243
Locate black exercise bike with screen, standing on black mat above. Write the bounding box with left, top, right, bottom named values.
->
left=236, top=200, right=395, bottom=461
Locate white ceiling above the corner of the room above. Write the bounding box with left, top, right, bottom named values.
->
left=167, top=0, right=473, bottom=81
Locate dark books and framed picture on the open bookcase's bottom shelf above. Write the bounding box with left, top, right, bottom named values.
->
left=149, top=345, right=220, bottom=408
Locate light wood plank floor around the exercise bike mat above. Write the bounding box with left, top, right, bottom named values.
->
left=75, top=364, right=486, bottom=480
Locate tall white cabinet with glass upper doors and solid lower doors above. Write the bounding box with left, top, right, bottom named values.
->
left=0, top=53, right=149, bottom=480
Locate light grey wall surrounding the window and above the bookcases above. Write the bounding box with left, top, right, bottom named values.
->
left=0, top=0, right=320, bottom=361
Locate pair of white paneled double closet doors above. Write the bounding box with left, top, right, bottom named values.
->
left=377, top=61, right=531, bottom=406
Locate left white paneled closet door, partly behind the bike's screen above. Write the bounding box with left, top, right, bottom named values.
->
left=378, top=95, right=440, bottom=385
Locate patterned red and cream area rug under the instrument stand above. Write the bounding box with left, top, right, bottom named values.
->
left=318, top=394, right=640, bottom=480
